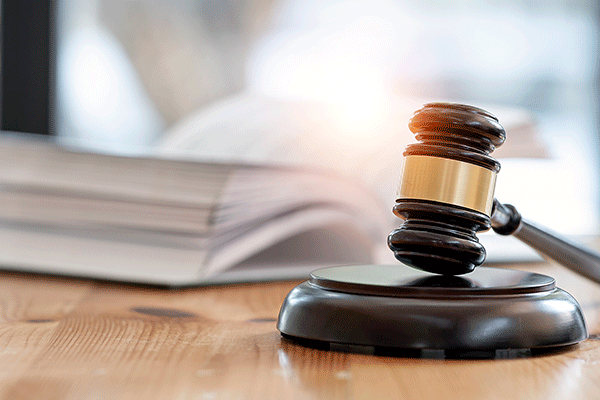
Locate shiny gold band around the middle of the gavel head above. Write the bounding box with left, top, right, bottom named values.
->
left=396, top=156, right=496, bottom=216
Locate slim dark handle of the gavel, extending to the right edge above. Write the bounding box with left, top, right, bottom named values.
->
left=491, top=199, right=600, bottom=283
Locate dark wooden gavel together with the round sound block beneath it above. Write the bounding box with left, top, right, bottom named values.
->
left=277, top=103, right=600, bottom=356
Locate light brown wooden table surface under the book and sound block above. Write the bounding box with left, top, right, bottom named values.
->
left=0, top=264, right=600, bottom=400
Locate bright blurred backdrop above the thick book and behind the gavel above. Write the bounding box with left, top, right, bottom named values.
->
left=1, top=0, right=600, bottom=244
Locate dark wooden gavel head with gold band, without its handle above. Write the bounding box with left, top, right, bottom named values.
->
left=388, top=103, right=506, bottom=275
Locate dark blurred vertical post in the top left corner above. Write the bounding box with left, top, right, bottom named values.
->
left=0, top=0, right=55, bottom=135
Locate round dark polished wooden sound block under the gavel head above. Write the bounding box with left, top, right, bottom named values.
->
left=277, top=265, right=587, bottom=351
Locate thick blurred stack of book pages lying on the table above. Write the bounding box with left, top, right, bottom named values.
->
left=0, top=134, right=389, bottom=285
